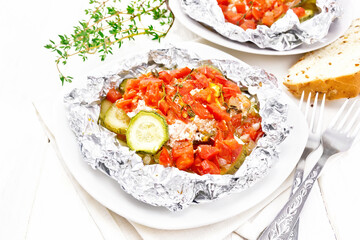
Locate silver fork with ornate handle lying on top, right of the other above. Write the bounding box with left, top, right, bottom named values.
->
left=258, top=100, right=360, bottom=240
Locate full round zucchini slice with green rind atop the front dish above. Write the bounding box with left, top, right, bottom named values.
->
left=126, top=111, right=169, bottom=154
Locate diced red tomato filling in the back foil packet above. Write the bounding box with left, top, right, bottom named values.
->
left=217, top=0, right=318, bottom=30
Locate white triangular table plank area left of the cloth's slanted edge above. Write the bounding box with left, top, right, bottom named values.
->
left=26, top=144, right=103, bottom=240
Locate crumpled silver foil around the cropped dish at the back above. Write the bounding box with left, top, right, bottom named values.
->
left=181, top=0, right=342, bottom=51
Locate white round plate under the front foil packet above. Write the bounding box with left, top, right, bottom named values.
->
left=54, top=43, right=308, bottom=230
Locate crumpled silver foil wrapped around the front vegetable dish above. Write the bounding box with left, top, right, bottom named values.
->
left=64, top=46, right=289, bottom=211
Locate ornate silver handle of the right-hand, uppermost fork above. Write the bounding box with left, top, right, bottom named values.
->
left=258, top=148, right=336, bottom=240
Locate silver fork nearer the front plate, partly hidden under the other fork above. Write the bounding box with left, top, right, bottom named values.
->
left=289, top=92, right=326, bottom=240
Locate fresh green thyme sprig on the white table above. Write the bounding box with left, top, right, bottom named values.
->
left=45, top=0, right=174, bottom=84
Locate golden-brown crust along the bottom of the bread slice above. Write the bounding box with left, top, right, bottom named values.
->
left=283, top=71, right=360, bottom=100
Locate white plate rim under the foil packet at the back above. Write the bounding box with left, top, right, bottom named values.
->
left=170, top=0, right=353, bottom=55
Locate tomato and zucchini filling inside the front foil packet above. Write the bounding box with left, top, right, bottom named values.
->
left=99, top=65, right=264, bottom=175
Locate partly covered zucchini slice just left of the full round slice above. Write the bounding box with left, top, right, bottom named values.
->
left=103, top=104, right=130, bottom=134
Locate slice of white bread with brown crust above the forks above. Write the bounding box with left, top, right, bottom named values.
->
left=284, top=18, right=360, bottom=99
